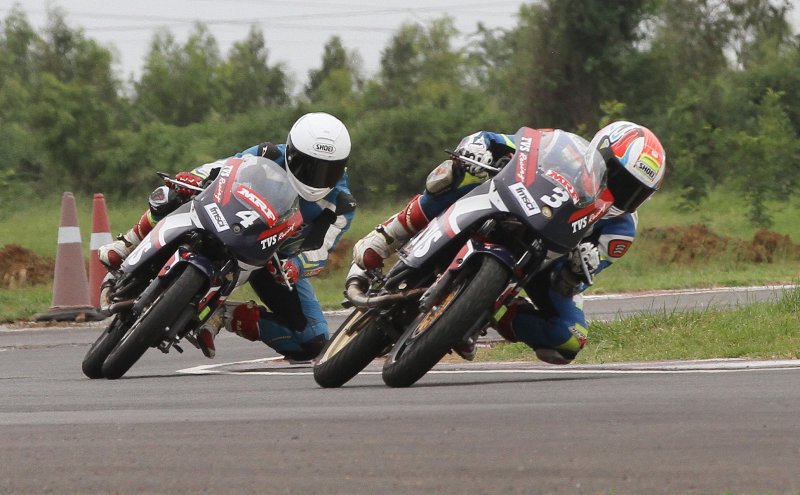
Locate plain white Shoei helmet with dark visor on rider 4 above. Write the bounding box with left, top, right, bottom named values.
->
left=286, top=112, right=350, bottom=201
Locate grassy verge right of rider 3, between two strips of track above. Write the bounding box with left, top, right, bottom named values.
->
left=476, top=290, right=800, bottom=364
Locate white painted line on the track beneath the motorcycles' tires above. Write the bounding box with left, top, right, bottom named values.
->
left=177, top=357, right=800, bottom=376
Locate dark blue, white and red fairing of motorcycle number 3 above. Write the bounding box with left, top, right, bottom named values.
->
left=401, top=127, right=610, bottom=267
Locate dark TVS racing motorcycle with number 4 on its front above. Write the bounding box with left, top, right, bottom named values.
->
left=82, top=156, right=302, bottom=379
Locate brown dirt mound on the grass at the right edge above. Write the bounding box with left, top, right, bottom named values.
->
left=642, top=224, right=800, bottom=265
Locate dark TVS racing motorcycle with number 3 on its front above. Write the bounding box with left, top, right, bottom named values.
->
left=314, top=127, right=611, bottom=388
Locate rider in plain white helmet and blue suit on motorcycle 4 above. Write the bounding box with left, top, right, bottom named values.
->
left=98, top=113, right=356, bottom=361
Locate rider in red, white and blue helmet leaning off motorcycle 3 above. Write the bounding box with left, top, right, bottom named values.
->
left=353, top=121, right=666, bottom=364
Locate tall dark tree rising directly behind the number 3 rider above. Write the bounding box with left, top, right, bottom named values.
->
left=505, top=0, right=648, bottom=129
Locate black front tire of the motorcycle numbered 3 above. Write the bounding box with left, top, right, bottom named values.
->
left=381, top=256, right=509, bottom=388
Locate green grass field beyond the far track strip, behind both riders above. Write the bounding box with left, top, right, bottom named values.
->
left=0, top=189, right=800, bottom=321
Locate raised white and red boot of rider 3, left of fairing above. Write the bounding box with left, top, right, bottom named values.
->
left=353, top=194, right=430, bottom=270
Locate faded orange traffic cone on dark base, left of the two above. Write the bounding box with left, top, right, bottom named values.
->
left=36, top=192, right=102, bottom=321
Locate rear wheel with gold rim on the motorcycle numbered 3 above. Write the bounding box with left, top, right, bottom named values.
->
left=314, top=309, right=391, bottom=388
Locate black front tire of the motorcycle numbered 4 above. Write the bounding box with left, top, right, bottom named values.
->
left=103, top=265, right=206, bottom=380
